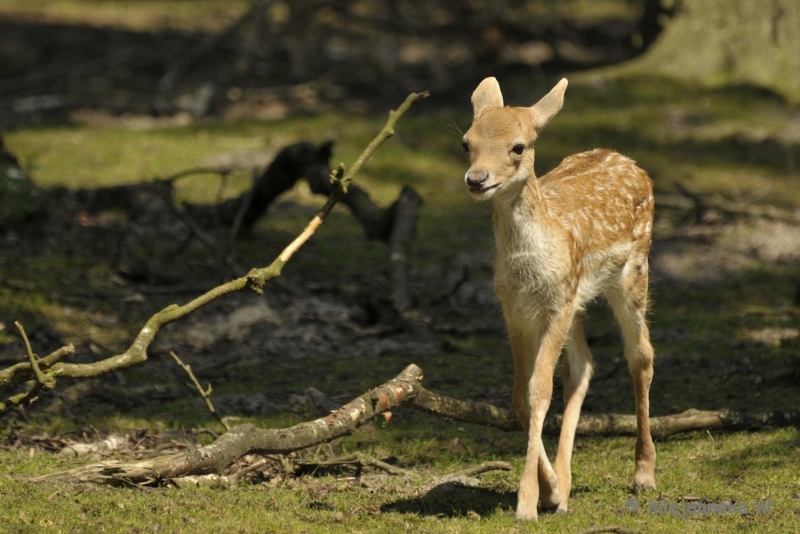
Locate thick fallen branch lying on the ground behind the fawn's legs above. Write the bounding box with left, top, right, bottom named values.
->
left=33, top=364, right=800, bottom=485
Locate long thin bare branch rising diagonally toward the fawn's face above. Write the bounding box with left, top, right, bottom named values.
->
left=0, top=92, right=428, bottom=402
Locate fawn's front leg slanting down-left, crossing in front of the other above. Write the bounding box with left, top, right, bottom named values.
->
left=516, top=305, right=574, bottom=520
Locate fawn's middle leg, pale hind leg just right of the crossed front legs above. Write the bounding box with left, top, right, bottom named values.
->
left=555, top=317, right=592, bottom=512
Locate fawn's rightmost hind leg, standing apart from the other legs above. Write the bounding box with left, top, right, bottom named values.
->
left=607, top=268, right=656, bottom=492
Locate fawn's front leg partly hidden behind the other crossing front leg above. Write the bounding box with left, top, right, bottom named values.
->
left=508, top=322, right=561, bottom=508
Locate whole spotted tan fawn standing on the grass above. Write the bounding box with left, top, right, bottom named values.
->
left=462, top=78, right=656, bottom=520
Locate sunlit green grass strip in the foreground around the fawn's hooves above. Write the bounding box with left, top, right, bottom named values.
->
left=0, top=416, right=800, bottom=533
